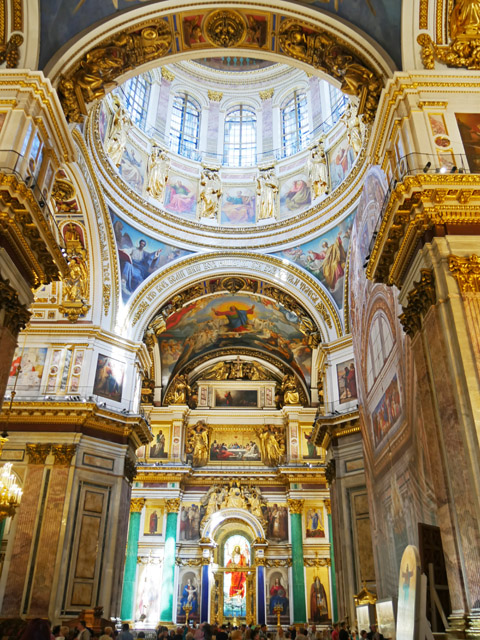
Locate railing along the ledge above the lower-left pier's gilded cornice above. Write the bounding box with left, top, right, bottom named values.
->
left=3, top=382, right=148, bottom=422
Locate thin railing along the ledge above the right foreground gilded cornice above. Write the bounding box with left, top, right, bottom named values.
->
left=365, top=153, right=470, bottom=263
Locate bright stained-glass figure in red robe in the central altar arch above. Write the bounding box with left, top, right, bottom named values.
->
left=223, top=534, right=251, bottom=618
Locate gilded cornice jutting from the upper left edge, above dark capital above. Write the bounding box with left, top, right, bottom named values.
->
left=0, top=172, right=68, bottom=286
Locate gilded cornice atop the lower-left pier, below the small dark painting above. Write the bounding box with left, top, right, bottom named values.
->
left=0, top=400, right=152, bottom=447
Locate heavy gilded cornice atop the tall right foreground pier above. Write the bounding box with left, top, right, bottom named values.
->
left=366, top=173, right=480, bottom=288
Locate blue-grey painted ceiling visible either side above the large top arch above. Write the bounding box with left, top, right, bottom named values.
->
left=39, top=0, right=402, bottom=69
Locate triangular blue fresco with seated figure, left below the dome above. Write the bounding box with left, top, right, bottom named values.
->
left=110, top=209, right=191, bottom=302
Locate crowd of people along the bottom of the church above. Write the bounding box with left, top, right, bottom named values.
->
left=12, top=618, right=384, bottom=640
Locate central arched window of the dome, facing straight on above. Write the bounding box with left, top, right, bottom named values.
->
left=223, top=105, right=257, bottom=167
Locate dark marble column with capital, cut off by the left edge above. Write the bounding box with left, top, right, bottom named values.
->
left=0, top=276, right=30, bottom=409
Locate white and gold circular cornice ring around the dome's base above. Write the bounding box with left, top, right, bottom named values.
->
left=89, top=105, right=370, bottom=250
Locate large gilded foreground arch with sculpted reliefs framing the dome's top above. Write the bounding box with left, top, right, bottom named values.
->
left=46, top=0, right=393, bottom=122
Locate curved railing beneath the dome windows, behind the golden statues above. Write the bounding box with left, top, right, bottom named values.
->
left=116, top=87, right=349, bottom=168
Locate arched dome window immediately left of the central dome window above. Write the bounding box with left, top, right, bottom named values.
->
left=170, top=93, right=200, bottom=160
